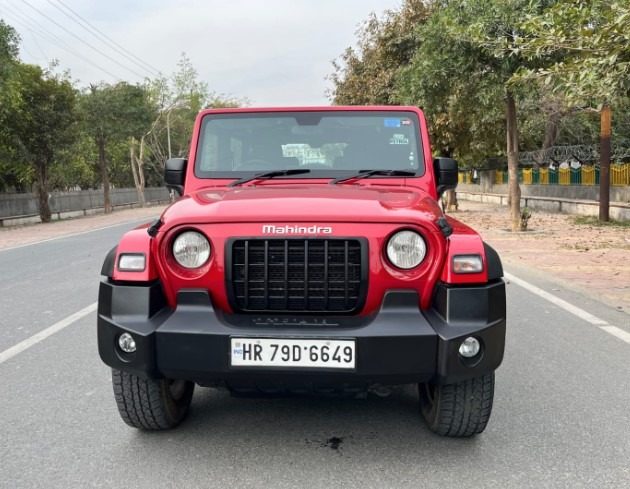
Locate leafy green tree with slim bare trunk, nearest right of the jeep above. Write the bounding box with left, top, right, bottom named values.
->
left=400, top=0, right=551, bottom=231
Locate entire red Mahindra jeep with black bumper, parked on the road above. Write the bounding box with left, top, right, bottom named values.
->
left=97, top=106, right=506, bottom=436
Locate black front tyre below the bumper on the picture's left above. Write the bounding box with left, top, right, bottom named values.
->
left=112, top=369, right=195, bottom=430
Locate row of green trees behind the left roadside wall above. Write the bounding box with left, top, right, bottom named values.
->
left=0, top=20, right=248, bottom=196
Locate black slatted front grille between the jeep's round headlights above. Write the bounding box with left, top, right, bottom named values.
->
left=226, top=238, right=367, bottom=313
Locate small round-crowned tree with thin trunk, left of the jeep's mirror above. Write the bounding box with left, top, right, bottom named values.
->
left=81, top=82, right=154, bottom=213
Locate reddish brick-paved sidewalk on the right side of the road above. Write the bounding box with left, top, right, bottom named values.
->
left=451, top=200, right=630, bottom=314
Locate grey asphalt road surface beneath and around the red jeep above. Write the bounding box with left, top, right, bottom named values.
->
left=0, top=224, right=630, bottom=489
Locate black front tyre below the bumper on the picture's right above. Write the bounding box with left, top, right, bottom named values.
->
left=418, top=372, right=494, bottom=437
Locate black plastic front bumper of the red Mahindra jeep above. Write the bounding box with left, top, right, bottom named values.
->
left=98, top=279, right=505, bottom=386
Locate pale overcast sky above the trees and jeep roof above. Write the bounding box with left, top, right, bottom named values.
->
left=0, top=0, right=402, bottom=106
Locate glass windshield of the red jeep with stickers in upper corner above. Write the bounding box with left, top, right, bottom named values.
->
left=195, top=111, right=424, bottom=178
